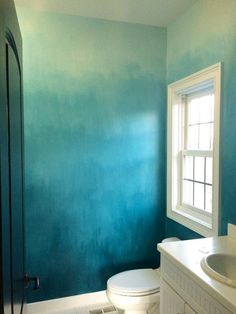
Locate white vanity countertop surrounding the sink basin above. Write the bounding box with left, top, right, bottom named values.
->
left=158, top=236, right=236, bottom=313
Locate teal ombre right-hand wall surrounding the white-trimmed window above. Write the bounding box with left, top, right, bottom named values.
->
left=166, top=0, right=236, bottom=239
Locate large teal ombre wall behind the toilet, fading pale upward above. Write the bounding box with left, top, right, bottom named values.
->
left=18, top=8, right=166, bottom=302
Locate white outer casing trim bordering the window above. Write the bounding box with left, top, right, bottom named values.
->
left=167, top=63, right=221, bottom=237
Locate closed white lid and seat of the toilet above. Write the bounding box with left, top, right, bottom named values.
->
left=107, top=269, right=160, bottom=295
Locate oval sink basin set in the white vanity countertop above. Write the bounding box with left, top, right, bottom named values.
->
left=201, top=253, right=236, bottom=287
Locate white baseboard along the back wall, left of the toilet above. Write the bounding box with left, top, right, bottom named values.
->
left=27, top=290, right=108, bottom=314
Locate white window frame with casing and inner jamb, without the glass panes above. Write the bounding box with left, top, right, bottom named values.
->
left=167, top=63, right=221, bottom=237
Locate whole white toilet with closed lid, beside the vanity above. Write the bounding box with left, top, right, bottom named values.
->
left=106, top=238, right=180, bottom=314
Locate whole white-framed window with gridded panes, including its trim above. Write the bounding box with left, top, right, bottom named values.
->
left=167, top=63, right=221, bottom=236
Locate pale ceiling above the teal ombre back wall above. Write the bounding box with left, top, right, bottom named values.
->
left=15, top=0, right=197, bottom=27
